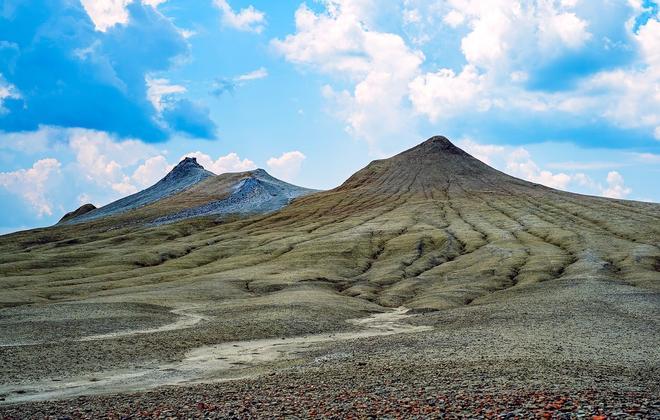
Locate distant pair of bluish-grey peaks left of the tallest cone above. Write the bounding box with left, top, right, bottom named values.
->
left=60, top=158, right=316, bottom=228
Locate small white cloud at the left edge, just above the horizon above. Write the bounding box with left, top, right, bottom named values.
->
left=0, top=158, right=61, bottom=217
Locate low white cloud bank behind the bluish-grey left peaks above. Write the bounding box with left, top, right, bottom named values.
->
left=0, top=127, right=256, bottom=226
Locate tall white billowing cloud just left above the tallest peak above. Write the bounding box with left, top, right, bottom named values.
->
left=272, top=0, right=424, bottom=149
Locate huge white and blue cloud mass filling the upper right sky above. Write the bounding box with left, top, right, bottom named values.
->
left=272, top=0, right=660, bottom=150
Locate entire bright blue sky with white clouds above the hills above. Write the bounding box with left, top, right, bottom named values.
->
left=0, top=0, right=660, bottom=234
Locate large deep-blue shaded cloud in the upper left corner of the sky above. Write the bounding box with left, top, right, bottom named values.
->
left=0, top=0, right=213, bottom=141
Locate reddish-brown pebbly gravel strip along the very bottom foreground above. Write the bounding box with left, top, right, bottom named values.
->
left=0, top=362, right=660, bottom=420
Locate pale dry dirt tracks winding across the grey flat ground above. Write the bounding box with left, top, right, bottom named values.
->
left=0, top=308, right=432, bottom=404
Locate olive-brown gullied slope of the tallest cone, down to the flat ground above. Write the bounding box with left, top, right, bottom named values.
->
left=0, top=137, right=660, bottom=309
